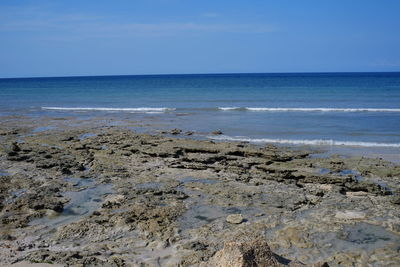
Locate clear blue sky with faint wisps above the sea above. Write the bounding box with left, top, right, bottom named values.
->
left=0, top=0, right=400, bottom=78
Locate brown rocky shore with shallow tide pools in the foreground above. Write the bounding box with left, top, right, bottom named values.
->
left=0, top=120, right=400, bottom=266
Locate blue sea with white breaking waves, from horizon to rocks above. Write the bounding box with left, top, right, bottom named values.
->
left=0, top=72, right=400, bottom=161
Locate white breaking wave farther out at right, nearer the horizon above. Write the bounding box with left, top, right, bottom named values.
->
left=218, top=107, right=400, bottom=112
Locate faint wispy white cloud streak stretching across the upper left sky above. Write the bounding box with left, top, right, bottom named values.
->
left=0, top=7, right=277, bottom=37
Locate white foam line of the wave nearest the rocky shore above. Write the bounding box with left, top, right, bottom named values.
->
left=208, top=135, right=400, bottom=148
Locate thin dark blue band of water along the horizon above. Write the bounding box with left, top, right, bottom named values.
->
left=0, top=71, right=400, bottom=80
